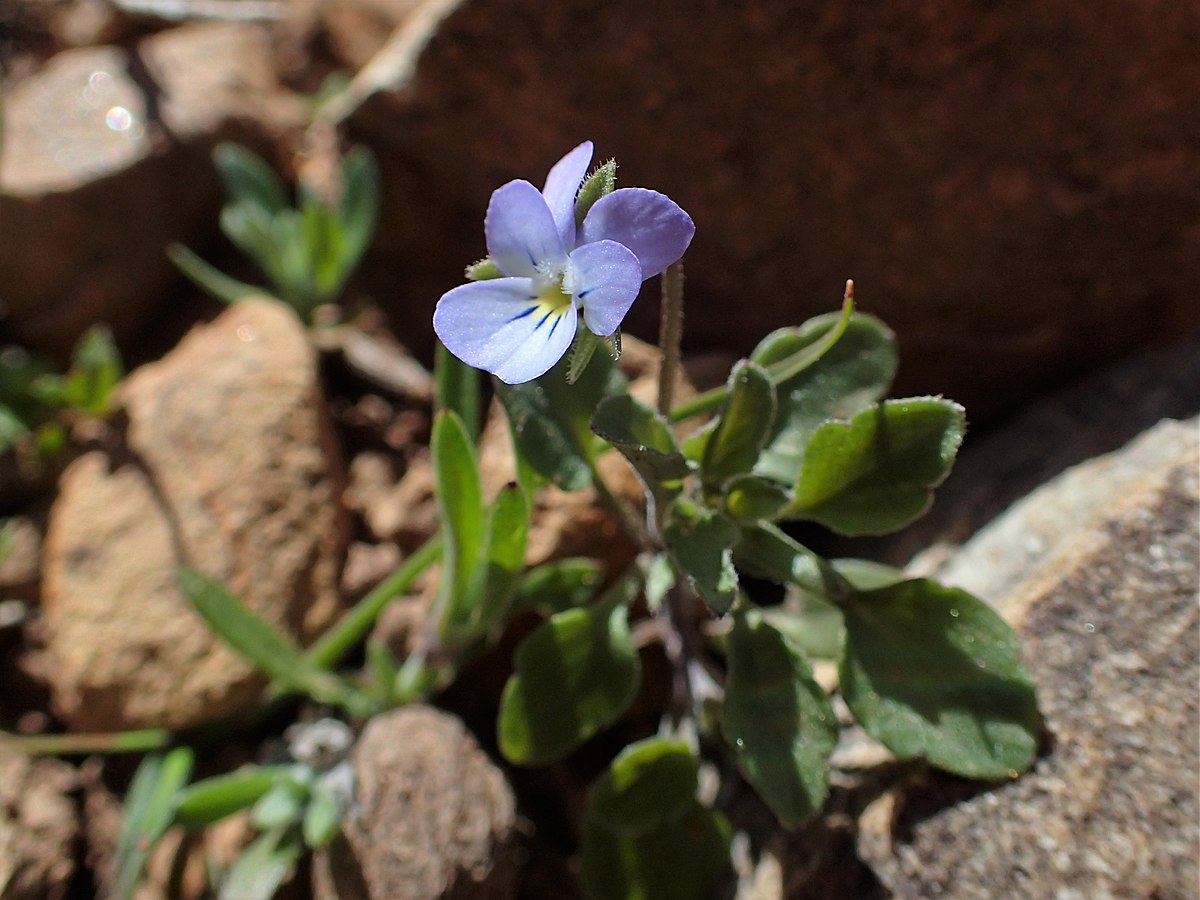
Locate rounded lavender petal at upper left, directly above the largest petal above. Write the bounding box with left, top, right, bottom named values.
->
left=484, top=181, right=566, bottom=276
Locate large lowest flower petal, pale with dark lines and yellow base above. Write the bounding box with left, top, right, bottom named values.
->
left=433, top=278, right=578, bottom=384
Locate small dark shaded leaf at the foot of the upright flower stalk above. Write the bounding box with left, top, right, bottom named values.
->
left=592, top=394, right=691, bottom=503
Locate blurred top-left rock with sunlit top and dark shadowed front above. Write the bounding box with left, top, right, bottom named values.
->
left=0, top=23, right=294, bottom=358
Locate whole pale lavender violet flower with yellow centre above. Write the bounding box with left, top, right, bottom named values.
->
left=433, top=140, right=696, bottom=384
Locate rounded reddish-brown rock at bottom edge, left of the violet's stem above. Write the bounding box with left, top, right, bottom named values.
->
left=313, top=706, right=520, bottom=900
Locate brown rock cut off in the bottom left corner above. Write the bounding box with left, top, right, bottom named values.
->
left=0, top=743, right=79, bottom=900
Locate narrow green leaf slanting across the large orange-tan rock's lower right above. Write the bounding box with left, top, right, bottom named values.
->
left=175, top=566, right=347, bottom=704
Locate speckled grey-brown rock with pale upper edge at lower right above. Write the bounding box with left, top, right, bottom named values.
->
left=858, top=419, right=1200, bottom=898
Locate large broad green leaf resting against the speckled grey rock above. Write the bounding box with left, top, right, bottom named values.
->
left=840, top=578, right=1040, bottom=779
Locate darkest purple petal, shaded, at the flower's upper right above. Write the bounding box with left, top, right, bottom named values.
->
left=578, top=187, right=696, bottom=280
